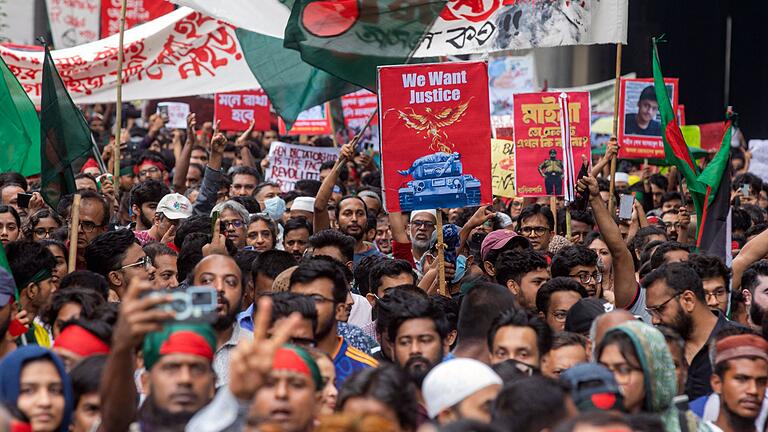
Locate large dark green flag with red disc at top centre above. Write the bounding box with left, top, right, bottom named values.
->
left=285, top=0, right=447, bottom=92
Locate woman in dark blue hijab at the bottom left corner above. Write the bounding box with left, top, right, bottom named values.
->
left=0, top=345, right=73, bottom=432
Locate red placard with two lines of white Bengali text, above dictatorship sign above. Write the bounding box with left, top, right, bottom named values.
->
left=213, top=89, right=270, bottom=131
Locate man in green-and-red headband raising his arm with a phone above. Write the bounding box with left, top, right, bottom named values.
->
left=100, top=279, right=216, bottom=431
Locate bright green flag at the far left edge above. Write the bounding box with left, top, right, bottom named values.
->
left=0, top=57, right=40, bottom=176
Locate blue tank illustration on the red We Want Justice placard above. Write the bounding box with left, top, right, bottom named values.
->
left=398, top=152, right=480, bottom=211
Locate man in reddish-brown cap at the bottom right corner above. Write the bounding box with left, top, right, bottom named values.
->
left=707, top=334, right=768, bottom=432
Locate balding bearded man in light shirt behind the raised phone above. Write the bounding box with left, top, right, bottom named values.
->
left=193, top=254, right=253, bottom=388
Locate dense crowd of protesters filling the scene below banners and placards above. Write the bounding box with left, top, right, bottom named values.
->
left=0, top=106, right=768, bottom=432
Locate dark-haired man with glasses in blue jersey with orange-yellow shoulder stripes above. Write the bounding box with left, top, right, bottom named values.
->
left=289, top=258, right=378, bottom=388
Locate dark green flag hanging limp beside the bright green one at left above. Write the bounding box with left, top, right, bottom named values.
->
left=40, top=46, right=92, bottom=209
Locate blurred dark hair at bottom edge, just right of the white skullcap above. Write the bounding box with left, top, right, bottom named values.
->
left=492, top=376, right=568, bottom=432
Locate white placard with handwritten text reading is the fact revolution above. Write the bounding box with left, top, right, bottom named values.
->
left=264, top=141, right=339, bottom=192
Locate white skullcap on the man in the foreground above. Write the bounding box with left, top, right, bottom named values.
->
left=421, top=358, right=502, bottom=418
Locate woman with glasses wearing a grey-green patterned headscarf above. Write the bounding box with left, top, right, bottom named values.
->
left=597, top=321, right=697, bottom=432
